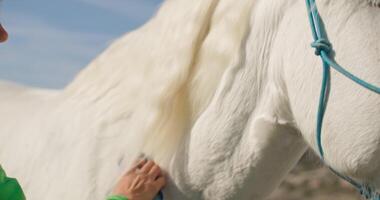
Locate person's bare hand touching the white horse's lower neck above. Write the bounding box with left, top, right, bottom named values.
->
left=113, top=160, right=166, bottom=200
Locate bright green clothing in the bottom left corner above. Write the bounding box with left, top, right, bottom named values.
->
left=0, top=166, right=25, bottom=200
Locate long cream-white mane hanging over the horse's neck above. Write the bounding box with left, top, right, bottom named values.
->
left=65, top=0, right=253, bottom=165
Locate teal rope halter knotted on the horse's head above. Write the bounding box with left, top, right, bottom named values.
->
left=306, top=0, right=380, bottom=200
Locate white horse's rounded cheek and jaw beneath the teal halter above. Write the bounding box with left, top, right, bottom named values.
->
left=280, top=0, right=380, bottom=189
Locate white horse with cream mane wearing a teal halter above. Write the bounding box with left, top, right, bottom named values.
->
left=0, top=0, right=380, bottom=200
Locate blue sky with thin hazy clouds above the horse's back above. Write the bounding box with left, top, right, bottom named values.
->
left=0, top=0, right=162, bottom=88
